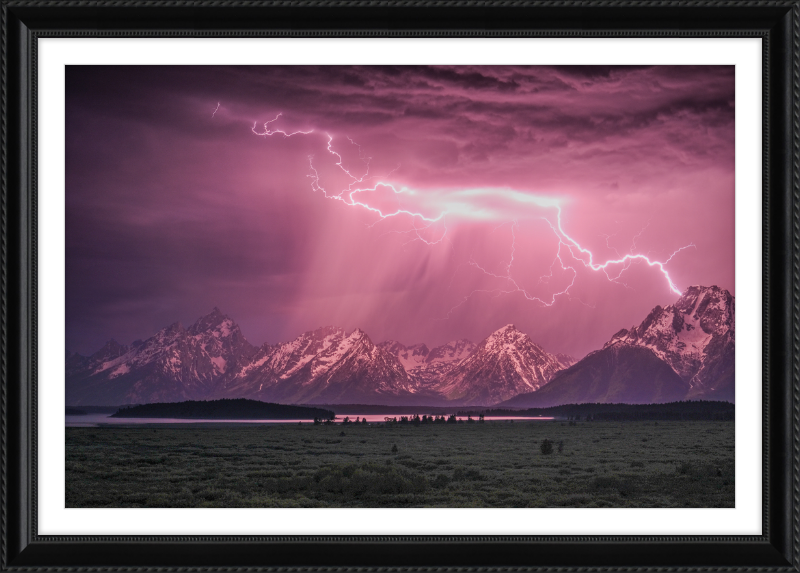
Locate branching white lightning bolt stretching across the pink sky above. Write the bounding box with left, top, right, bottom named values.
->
left=252, top=113, right=697, bottom=312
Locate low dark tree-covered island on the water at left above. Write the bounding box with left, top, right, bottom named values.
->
left=111, top=398, right=336, bottom=420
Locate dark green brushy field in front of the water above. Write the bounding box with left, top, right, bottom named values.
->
left=66, top=421, right=734, bottom=507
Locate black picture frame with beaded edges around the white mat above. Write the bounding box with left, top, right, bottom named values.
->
left=0, top=0, right=800, bottom=572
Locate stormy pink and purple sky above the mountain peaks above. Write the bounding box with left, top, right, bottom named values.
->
left=66, top=66, right=735, bottom=357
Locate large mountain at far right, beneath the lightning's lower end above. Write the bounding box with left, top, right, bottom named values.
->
left=499, top=286, right=736, bottom=408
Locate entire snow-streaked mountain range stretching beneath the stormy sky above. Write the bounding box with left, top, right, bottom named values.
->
left=66, top=286, right=735, bottom=407
